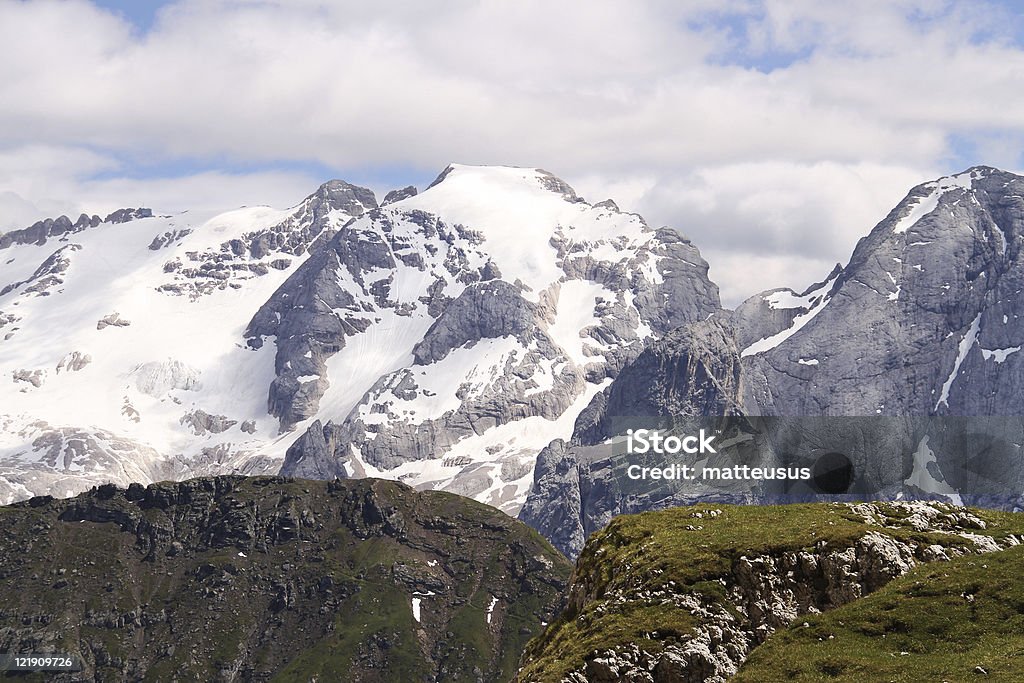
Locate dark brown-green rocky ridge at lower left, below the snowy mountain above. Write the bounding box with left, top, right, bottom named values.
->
left=0, top=476, right=570, bottom=683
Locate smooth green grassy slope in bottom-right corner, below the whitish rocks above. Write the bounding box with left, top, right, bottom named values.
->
left=733, top=546, right=1024, bottom=683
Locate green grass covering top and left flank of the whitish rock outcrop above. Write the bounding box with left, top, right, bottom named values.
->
left=518, top=504, right=1024, bottom=681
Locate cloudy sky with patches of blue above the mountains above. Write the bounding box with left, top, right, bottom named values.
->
left=0, top=0, right=1024, bottom=304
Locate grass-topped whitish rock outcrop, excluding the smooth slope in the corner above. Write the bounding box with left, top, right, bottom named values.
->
left=517, top=503, right=1024, bottom=683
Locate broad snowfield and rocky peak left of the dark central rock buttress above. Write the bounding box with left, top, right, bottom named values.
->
left=0, top=183, right=376, bottom=501
